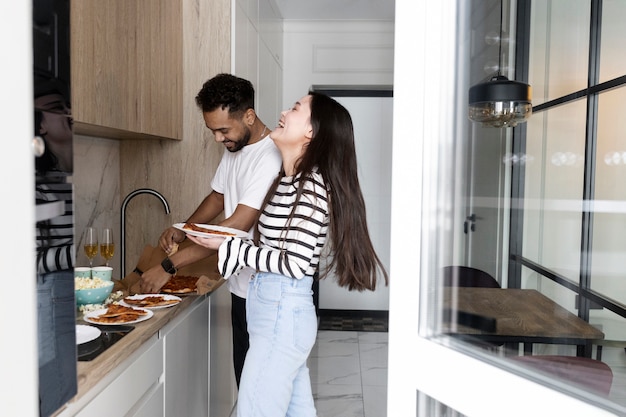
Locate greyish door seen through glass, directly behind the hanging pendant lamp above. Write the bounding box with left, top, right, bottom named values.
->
left=460, top=0, right=514, bottom=278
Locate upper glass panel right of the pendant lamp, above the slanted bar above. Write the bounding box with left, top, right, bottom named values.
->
left=529, top=0, right=590, bottom=106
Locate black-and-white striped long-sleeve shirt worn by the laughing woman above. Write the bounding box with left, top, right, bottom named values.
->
left=218, top=173, right=328, bottom=279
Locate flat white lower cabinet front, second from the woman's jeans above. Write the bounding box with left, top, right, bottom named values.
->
left=159, top=297, right=211, bottom=417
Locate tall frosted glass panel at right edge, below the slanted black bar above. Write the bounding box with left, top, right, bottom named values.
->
left=591, top=88, right=626, bottom=306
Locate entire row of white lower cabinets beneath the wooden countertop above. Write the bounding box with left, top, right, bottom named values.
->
left=55, top=291, right=236, bottom=417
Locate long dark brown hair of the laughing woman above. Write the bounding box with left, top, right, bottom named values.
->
left=256, top=92, right=389, bottom=291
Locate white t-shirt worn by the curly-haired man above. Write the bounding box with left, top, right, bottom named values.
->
left=211, top=135, right=282, bottom=298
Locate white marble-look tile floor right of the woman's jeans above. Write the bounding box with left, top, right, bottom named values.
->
left=231, top=330, right=388, bottom=417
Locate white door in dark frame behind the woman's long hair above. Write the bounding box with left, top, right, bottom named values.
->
left=319, top=90, right=393, bottom=311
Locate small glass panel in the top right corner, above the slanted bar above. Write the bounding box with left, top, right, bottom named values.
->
left=600, top=0, right=626, bottom=82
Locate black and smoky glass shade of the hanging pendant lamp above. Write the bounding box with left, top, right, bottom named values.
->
left=469, top=75, right=532, bottom=127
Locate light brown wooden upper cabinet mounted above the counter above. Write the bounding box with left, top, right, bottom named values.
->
left=70, top=0, right=183, bottom=139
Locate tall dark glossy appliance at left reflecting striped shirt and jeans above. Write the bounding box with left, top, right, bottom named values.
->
left=33, top=0, right=77, bottom=417
